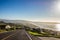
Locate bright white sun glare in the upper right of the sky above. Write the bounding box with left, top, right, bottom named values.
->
left=51, top=0, right=60, bottom=15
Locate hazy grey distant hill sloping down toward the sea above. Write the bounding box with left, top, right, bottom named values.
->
left=0, top=19, right=37, bottom=28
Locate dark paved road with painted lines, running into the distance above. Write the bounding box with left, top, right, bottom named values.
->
left=0, top=30, right=40, bottom=40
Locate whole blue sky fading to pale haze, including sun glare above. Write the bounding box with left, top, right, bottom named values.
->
left=0, top=0, right=60, bottom=21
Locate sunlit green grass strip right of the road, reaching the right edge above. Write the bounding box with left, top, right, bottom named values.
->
left=28, top=31, right=60, bottom=38
